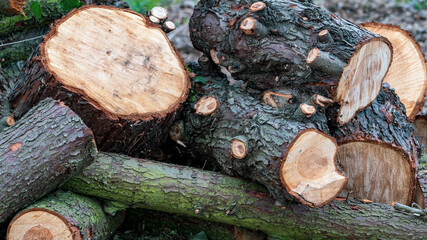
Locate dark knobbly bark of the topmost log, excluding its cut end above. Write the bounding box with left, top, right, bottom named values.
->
left=190, top=0, right=389, bottom=89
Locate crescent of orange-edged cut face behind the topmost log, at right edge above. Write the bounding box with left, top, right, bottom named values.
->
left=362, top=22, right=427, bottom=122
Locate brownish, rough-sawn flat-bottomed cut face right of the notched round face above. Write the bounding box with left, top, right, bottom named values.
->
left=337, top=142, right=414, bottom=204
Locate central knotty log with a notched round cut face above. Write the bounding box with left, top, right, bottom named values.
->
left=171, top=69, right=347, bottom=207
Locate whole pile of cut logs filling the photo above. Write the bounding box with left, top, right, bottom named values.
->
left=0, top=0, right=427, bottom=240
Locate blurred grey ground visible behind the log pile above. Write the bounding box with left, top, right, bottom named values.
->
left=169, top=0, right=427, bottom=62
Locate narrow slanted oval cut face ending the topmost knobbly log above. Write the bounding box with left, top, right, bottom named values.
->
left=334, top=39, right=392, bottom=124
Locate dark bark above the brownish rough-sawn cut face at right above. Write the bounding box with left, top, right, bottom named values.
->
left=328, top=83, right=423, bottom=170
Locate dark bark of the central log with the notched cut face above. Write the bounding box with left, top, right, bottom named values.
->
left=177, top=68, right=329, bottom=204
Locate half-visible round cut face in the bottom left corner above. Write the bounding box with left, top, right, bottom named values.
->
left=7, top=211, right=73, bottom=240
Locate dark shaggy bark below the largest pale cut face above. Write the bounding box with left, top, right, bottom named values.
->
left=9, top=48, right=177, bottom=156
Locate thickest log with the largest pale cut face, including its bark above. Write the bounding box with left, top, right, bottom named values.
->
left=10, top=6, right=190, bottom=156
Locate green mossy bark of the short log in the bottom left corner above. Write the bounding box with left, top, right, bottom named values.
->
left=8, top=191, right=124, bottom=239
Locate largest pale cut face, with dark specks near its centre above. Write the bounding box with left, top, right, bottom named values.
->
left=45, top=7, right=188, bottom=118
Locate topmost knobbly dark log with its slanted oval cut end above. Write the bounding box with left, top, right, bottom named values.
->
left=190, top=0, right=392, bottom=124
